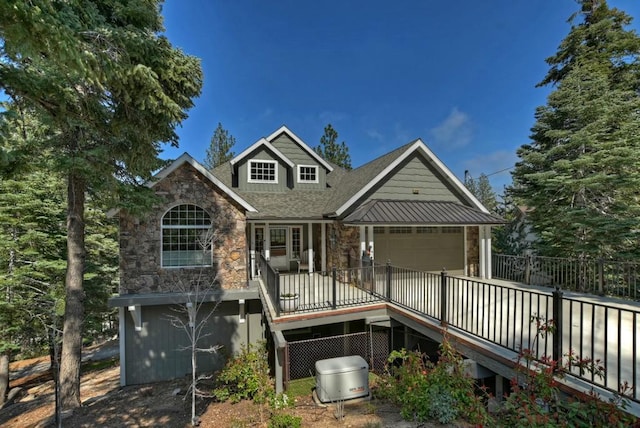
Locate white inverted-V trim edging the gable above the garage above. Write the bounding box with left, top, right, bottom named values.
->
left=335, top=138, right=490, bottom=216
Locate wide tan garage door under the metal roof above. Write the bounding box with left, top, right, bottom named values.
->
left=373, top=226, right=464, bottom=272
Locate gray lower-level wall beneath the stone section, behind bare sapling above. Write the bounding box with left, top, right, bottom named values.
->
left=121, top=300, right=263, bottom=385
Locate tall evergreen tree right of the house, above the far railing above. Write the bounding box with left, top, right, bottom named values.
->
left=512, top=0, right=640, bottom=258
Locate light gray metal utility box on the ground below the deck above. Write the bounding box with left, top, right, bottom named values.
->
left=316, top=355, right=369, bottom=403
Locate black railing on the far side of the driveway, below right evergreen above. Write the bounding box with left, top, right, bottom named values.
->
left=492, top=254, right=640, bottom=300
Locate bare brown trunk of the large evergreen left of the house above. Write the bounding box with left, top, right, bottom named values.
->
left=60, top=172, right=86, bottom=410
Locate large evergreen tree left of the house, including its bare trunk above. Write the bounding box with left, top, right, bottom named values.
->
left=0, top=0, right=202, bottom=409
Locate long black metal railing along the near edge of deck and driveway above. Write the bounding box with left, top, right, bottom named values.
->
left=261, top=261, right=640, bottom=403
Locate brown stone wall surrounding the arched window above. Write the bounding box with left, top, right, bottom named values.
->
left=120, top=164, right=248, bottom=294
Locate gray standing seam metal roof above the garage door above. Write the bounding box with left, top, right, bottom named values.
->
left=343, top=199, right=504, bottom=225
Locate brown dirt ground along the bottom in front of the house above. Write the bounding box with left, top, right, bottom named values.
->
left=0, top=352, right=450, bottom=428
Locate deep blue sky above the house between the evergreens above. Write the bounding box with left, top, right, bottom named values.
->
left=162, top=0, right=640, bottom=193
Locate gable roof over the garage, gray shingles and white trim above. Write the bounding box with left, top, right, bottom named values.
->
left=326, top=139, right=489, bottom=217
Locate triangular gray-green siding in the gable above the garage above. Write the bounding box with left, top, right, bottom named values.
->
left=367, top=155, right=466, bottom=205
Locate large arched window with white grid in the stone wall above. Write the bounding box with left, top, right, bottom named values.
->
left=162, top=204, right=212, bottom=267
